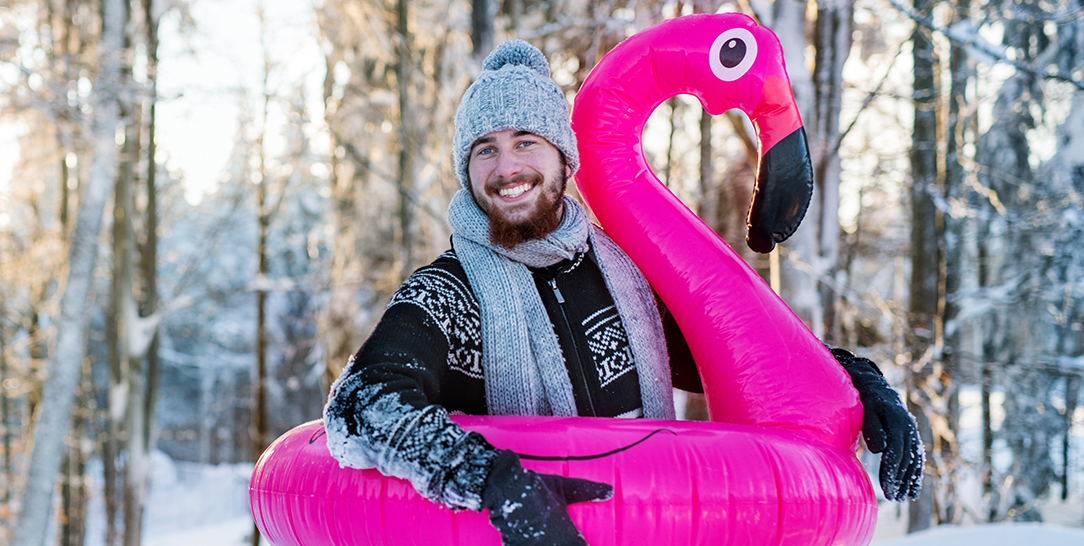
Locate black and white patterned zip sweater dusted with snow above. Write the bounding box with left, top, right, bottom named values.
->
left=324, top=245, right=702, bottom=510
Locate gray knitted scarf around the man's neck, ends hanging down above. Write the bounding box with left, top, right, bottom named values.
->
left=448, top=190, right=674, bottom=419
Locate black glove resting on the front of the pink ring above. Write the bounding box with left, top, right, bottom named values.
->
left=481, top=450, right=614, bottom=546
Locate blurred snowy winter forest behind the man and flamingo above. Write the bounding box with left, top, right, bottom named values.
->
left=0, top=0, right=1084, bottom=546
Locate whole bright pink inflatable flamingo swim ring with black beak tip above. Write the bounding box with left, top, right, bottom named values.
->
left=249, top=14, right=877, bottom=546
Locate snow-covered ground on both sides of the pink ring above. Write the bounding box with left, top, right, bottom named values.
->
left=78, top=453, right=1084, bottom=546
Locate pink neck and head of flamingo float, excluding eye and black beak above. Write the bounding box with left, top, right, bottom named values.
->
left=572, top=13, right=862, bottom=449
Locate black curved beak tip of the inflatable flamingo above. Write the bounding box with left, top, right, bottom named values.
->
left=746, top=126, right=813, bottom=254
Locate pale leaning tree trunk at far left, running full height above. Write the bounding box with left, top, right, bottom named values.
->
left=13, top=0, right=125, bottom=546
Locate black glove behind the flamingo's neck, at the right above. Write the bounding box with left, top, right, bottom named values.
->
left=831, top=349, right=926, bottom=502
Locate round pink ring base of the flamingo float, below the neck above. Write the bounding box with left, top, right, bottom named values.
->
left=250, top=417, right=877, bottom=546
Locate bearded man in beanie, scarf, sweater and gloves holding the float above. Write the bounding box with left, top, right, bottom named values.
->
left=324, top=40, right=922, bottom=545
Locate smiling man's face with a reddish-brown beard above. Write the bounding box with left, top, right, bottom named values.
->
left=467, top=129, right=571, bottom=248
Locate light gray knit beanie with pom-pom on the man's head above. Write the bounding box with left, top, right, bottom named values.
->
left=452, top=40, right=580, bottom=190
